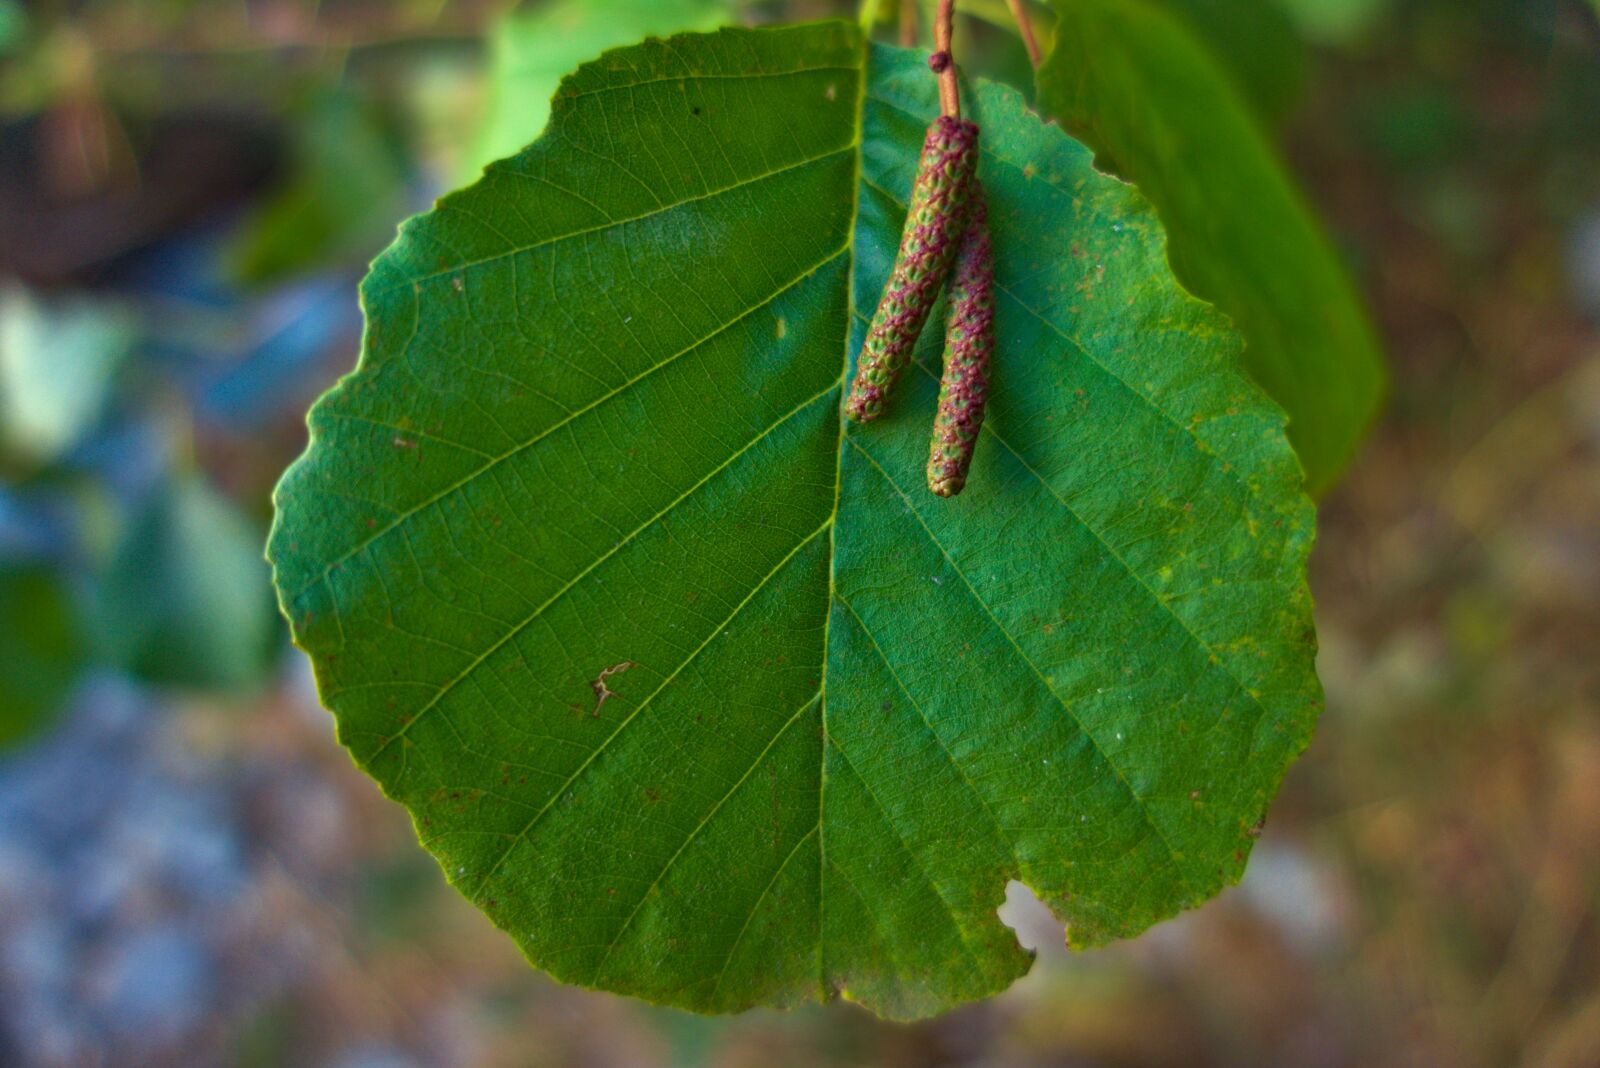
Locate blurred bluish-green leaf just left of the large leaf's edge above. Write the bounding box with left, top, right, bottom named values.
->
left=98, top=475, right=277, bottom=692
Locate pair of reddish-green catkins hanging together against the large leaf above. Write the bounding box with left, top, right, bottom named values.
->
left=845, top=115, right=994, bottom=497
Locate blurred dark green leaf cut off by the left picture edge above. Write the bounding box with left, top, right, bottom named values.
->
left=0, top=563, right=85, bottom=750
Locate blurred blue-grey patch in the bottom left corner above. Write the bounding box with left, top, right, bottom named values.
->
left=0, top=678, right=248, bottom=1066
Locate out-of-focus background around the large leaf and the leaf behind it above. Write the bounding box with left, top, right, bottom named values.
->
left=0, top=0, right=1600, bottom=1068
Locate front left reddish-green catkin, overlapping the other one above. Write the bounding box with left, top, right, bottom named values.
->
left=845, top=115, right=978, bottom=422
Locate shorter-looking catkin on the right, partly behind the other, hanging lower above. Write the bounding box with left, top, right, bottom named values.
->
left=928, top=177, right=995, bottom=497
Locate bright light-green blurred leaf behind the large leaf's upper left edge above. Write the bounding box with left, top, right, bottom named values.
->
left=461, top=0, right=736, bottom=181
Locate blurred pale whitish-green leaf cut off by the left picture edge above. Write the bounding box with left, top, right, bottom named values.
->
left=0, top=286, right=138, bottom=462
